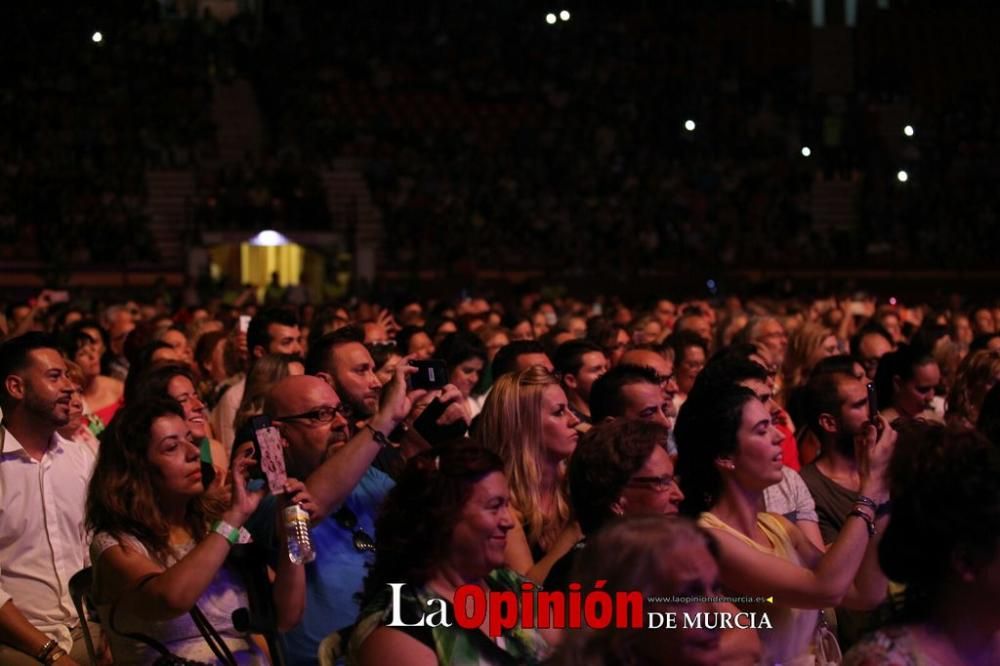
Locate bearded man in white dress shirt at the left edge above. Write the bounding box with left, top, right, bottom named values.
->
left=0, top=333, right=94, bottom=666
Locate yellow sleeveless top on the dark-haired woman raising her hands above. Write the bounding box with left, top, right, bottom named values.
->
left=698, top=511, right=819, bottom=666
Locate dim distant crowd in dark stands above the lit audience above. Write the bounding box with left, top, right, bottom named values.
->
left=0, top=2, right=997, bottom=274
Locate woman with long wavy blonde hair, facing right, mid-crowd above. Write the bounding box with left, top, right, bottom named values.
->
left=476, top=366, right=580, bottom=582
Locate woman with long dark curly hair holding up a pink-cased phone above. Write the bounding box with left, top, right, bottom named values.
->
left=86, top=398, right=311, bottom=664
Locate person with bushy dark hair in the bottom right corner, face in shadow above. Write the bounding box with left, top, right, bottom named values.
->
left=844, top=422, right=1000, bottom=666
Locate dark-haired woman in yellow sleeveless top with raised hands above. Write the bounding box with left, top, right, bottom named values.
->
left=674, top=386, right=895, bottom=666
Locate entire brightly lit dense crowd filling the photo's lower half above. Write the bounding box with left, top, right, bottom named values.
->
left=0, top=292, right=1000, bottom=666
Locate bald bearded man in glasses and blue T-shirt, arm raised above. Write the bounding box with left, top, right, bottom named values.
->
left=248, top=363, right=417, bottom=665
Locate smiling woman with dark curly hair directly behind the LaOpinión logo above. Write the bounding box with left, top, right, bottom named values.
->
left=348, top=444, right=549, bottom=666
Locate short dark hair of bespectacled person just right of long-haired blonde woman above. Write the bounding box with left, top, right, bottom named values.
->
left=567, top=419, right=670, bottom=534
